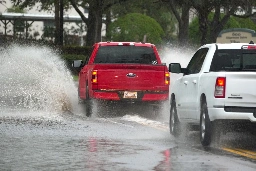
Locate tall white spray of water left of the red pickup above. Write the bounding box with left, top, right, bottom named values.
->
left=0, top=44, right=77, bottom=115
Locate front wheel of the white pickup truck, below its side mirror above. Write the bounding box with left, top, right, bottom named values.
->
left=169, top=99, right=181, bottom=137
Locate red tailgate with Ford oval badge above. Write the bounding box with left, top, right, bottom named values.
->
left=94, top=64, right=169, bottom=90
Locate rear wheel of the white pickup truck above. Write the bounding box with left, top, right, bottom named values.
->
left=200, top=103, right=212, bottom=146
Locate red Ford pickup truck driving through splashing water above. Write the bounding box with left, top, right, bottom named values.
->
left=73, top=42, right=170, bottom=116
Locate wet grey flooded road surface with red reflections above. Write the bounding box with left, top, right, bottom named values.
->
left=0, top=106, right=256, bottom=171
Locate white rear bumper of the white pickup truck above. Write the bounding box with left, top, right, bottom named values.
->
left=208, top=107, right=256, bottom=123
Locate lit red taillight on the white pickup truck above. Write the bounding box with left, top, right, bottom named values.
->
left=214, top=77, right=226, bottom=98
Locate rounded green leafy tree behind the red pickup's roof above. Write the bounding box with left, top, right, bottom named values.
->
left=110, top=13, right=164, bottom=44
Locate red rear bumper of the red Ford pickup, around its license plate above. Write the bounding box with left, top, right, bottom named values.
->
left=92, top=91, right=169, bottom=101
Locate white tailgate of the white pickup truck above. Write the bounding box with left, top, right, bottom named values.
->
left=225, top=72, right=256, bottom=107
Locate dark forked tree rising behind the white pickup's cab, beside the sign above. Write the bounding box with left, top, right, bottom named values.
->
left=191, top=0, right=256, bottom=44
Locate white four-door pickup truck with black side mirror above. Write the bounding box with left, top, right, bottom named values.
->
left=169, top=42, right=256, bottom=146
